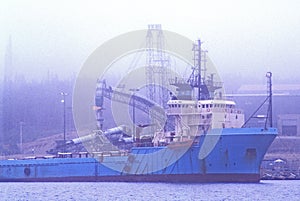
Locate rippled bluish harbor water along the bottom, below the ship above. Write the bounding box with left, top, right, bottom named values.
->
left=0, top=180, right=300, bottom=201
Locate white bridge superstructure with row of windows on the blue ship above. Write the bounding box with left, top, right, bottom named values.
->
left=167, top=99, right=244, bottom=136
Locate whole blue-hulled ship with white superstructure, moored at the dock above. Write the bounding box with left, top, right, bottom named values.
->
left=0, top=35, right=277, bottom=182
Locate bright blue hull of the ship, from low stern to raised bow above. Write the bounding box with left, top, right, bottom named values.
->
left=0, top=128, right=277, bottom=182
